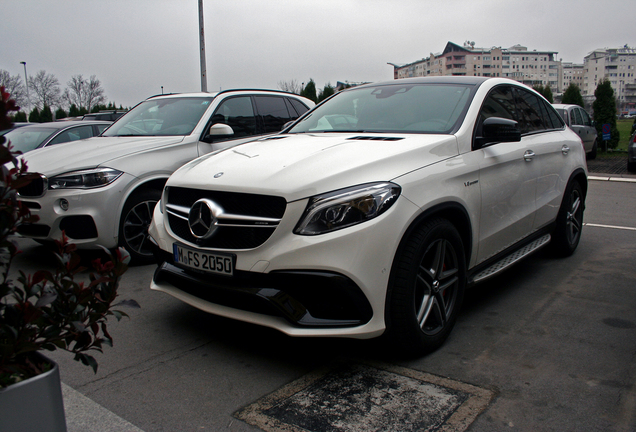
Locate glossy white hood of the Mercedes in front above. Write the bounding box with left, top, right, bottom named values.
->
left=168, top=133, right=458, bottom=202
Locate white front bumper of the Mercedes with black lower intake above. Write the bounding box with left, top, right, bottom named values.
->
left=149, top=194, right=416, bottom=338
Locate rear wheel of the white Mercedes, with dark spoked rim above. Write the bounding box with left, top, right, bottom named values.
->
left=552, top=180, right=585, bottom=257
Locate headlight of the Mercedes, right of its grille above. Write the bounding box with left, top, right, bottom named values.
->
left=294, top=183, right=400, bottom=235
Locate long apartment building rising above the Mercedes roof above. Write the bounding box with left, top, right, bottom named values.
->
left=389, top=41, right=563, bottom=92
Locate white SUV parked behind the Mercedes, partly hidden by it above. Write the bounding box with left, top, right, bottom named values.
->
left=18, top=90, right=314, bottom=264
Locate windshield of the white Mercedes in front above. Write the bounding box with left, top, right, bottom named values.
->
left=289, top=84, right=472, bottom=133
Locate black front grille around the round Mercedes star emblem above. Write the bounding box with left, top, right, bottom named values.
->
left=167, top=187, right=287, bottom=249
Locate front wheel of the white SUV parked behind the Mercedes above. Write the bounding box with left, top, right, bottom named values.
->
left=119, top=189, right=161, bottom=265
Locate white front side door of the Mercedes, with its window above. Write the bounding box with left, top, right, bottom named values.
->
left=476, top=85, right=537, bottom=263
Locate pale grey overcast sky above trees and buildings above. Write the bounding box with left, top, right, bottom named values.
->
left=0, top=0, right=636, bottom=107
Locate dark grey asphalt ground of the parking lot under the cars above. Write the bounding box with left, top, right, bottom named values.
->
left=9, top=174, right=636, bottom=432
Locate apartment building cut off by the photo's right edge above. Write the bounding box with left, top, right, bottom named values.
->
left=581, top=45, right=636, bottom=112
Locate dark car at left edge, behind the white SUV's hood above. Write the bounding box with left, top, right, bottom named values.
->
left=5, top=121, right=112, bottom=153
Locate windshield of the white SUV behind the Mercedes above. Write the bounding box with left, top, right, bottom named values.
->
left=102, top=97, right=214, bottom=136
